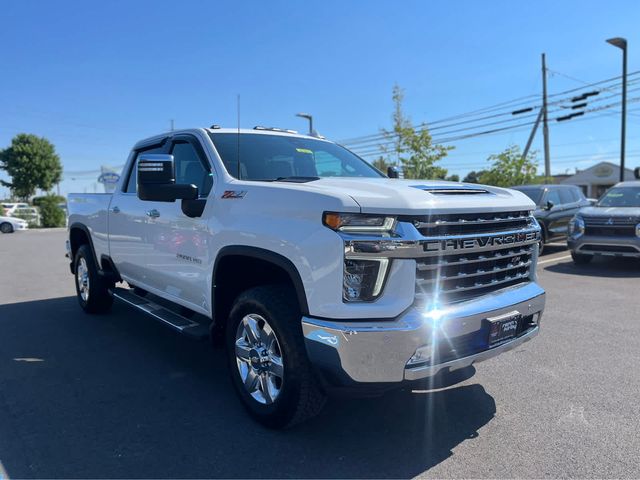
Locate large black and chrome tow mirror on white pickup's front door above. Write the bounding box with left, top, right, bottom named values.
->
left=137, top=154, right=198, bottom=202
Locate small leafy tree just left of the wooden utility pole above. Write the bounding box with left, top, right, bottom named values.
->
left=480, top=145, right=538, bottom=187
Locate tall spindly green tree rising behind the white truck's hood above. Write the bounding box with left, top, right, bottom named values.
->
left=380, top=85, right=453, bottom=179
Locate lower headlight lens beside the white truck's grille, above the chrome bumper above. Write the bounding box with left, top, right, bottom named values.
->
left=342, top=258, right=389, bottom=302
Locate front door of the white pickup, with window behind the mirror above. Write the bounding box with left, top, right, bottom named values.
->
left=143, top=135, right=213, bottom=310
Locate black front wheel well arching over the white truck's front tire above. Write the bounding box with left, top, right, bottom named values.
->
left=213, top=254, right=308, bottom=328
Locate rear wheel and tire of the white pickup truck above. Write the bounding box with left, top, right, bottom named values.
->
left=74, top=244, right=114, bottom=313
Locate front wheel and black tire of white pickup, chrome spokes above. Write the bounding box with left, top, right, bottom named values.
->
left=225, top=285, right=326, bottom=428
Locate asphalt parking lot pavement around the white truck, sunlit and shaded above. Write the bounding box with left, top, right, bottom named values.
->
left=0, top=231, right=640, bottom=478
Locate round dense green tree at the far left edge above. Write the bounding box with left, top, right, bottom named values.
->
left=0, top=133, right=62, bottom=200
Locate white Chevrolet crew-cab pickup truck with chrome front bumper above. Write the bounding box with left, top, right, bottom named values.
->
left=67, top=127, right=545, bottom=428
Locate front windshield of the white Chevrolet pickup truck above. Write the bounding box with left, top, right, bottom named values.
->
left=209, top=132, right=383, bottom=180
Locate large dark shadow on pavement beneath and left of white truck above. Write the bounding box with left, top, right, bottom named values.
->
left=0, top=297, right=496, bottom=478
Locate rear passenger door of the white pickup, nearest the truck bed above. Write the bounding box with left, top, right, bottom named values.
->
left=108, top=142, right=168, bottom=288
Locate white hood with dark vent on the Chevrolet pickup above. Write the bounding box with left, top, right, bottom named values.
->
left=299, top=177, right=535, bottom=214
